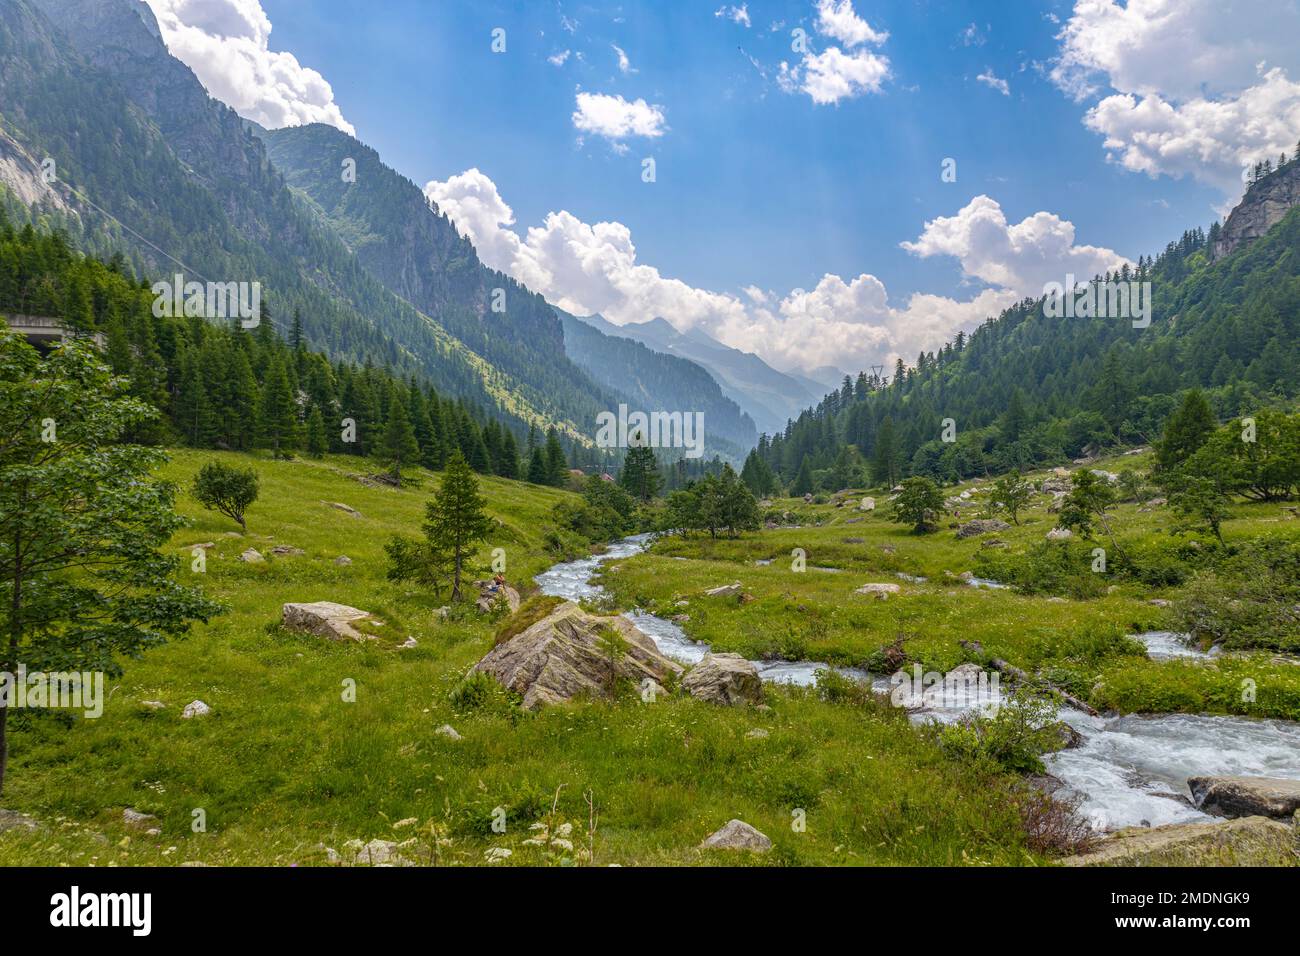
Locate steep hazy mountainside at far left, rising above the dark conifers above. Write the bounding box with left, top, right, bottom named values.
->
left=0, top=0, right=589, bottom=437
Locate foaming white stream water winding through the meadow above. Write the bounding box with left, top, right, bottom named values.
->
left=536, top=535, right=1300, bottom=830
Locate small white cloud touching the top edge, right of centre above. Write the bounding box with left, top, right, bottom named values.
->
left=776, top=0, right=889, bottom=105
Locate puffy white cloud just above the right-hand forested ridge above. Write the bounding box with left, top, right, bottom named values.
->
left=901, top=195, right=1128, bottom=297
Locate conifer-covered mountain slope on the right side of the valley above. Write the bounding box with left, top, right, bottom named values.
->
left=757, top=159, right=1300, bottom=484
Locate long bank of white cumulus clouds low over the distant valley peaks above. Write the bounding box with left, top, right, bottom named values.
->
left=425, top=169, right=1123, bottom=371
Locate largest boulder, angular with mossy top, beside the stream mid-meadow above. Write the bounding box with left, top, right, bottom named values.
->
left=473, top=601, right=681, bottom=708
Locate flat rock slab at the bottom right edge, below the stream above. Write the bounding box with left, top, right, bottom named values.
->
left=1061, top=817, right=1295, bottom=866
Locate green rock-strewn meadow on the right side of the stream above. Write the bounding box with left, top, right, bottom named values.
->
left=602, top=457, right=1300, bottom=719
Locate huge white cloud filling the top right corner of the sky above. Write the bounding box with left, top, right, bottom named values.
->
left=1050, top=0, right=1300, bottom=199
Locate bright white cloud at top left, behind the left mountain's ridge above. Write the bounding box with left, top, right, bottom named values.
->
left=147, top=0, right=356, bottom=134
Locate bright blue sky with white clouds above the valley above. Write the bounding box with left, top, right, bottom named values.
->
left=142, top=0, right=1300, bottom=371
